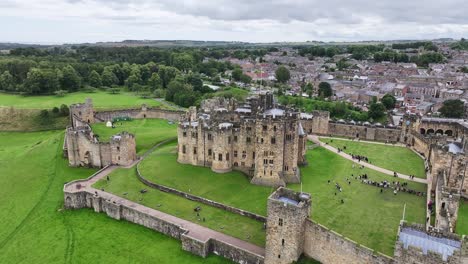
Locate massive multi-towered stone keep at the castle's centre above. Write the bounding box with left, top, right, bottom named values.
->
left=178, top=93, right=306, bottom=186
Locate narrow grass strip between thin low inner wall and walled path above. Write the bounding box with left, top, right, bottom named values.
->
left=94, top=168, right=265, bottom=246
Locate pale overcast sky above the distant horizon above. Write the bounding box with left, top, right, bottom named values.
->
left=0, top=0, right=468, bottom=43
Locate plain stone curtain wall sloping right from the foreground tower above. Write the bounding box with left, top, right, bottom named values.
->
left=304, top=219, right=394, bottom=264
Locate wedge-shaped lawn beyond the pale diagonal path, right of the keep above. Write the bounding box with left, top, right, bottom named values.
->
left=320, top=138, right=426, bottom=179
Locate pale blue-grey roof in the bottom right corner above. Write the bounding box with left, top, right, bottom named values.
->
left=398, top=227, right=461, bottom=261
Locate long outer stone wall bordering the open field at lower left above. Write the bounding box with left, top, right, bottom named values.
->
left=64, top=174, right=264, bottom=264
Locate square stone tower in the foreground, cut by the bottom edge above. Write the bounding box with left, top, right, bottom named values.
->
left=265, top=187, right=311, bottom=264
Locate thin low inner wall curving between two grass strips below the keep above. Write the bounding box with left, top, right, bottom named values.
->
left=137, top=167, right=266, bottom=223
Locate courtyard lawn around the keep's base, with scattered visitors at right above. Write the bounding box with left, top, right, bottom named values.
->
left=140, top=143, right=426, bottom=255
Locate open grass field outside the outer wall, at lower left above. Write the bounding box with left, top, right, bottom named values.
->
left=0, top=131, right=230, bottom=263
